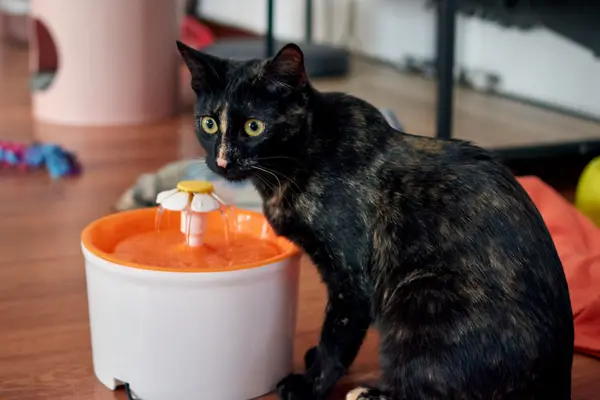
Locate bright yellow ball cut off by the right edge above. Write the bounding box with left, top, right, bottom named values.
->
left=575, top=156, right=600, bottom=226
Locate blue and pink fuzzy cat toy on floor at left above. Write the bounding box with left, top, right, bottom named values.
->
left=0, top=141, right=80, bottom=179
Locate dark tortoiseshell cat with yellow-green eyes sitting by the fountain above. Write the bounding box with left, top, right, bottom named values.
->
left=178, top=43, right=573, bottom=400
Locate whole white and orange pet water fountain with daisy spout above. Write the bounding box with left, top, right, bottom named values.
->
left=82, top=181, right=299, bottom=400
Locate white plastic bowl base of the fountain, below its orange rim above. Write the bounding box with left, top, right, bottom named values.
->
left=83, top=247, right=299, bottom=400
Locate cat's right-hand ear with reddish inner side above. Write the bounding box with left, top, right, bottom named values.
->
left=261, top=43, right=308, bottom=94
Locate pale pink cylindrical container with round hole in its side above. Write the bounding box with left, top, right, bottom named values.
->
left=30, top=0, right=180, bottom=125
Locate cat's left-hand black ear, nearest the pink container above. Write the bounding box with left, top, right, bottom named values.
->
left=177, top=41, right=227, bottom=93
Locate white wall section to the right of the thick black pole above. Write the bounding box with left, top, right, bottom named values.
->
left=461, top=19, right=600, bottom=117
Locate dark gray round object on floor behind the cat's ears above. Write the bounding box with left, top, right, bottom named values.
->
left=202, top=38, right=350, bottom=78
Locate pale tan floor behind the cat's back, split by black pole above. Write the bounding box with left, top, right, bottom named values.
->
left=316, top=61, right=600, bottom=148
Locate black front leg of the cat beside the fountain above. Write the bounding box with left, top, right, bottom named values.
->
left=277, top=288, right=371, bottom=400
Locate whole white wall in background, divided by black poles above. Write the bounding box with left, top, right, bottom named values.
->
left=201, top=0, right=600, bottom=118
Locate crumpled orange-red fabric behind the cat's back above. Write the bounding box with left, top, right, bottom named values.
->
left=519, top=176, right=600, bottom=358
